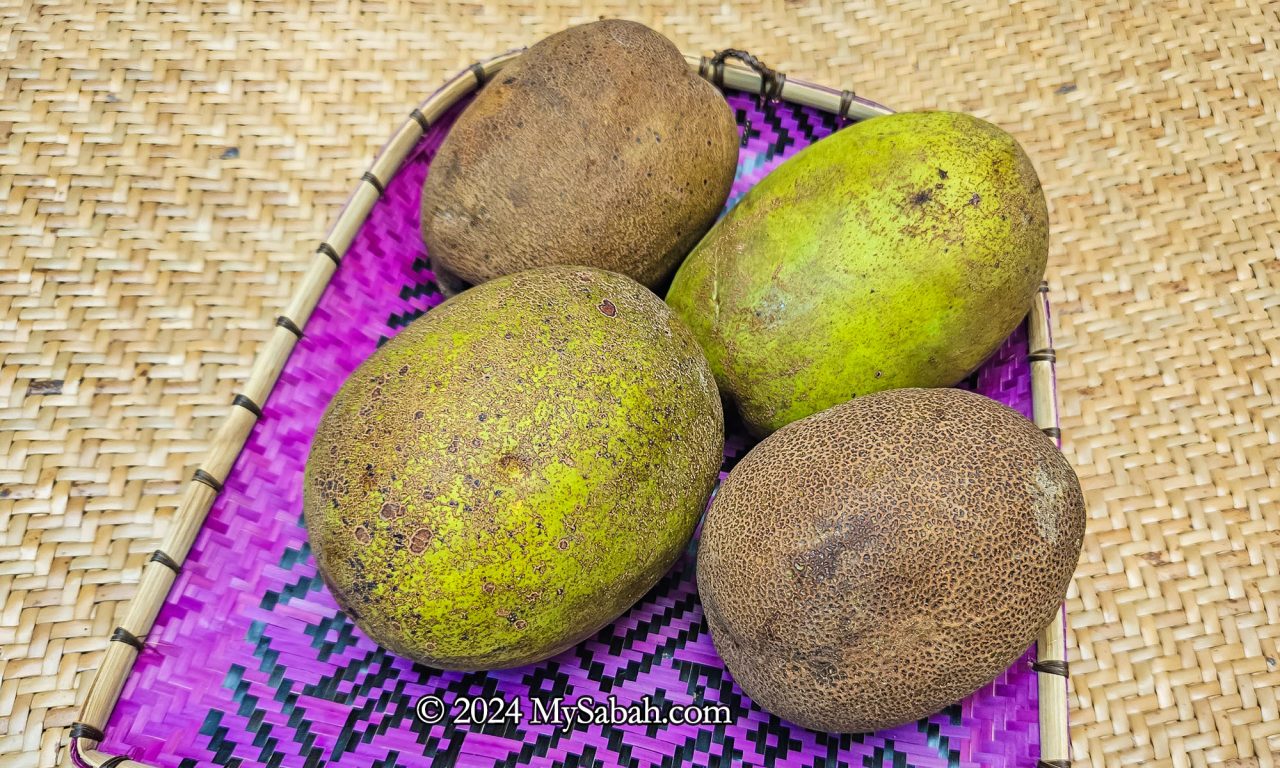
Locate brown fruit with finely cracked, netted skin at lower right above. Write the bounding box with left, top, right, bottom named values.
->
left=698, top=389, right=1084, bottom=732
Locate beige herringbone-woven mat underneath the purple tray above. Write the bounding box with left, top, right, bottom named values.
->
left=0, top=0, right=1280, bottom=765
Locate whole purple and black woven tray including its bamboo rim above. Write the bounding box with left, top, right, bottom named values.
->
left=70, top=51, right=1069, bottom=768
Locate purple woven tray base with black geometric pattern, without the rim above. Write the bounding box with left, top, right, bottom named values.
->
left=102, top=87, right=1038, bottom=768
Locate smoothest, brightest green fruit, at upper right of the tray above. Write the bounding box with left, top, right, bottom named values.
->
left=667, top=113, right=1048, bottom=435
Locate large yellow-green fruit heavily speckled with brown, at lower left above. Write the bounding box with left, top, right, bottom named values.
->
left=305, top=266, right=724, bottom=669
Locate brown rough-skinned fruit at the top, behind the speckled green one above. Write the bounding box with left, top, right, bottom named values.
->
left=422, top=19, right=737, bottom=288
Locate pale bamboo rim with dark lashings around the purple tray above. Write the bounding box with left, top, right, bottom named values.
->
left=69, top=50, right=1070, bottom=768
